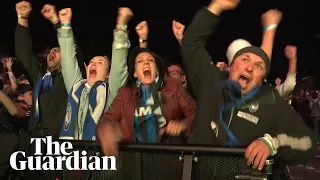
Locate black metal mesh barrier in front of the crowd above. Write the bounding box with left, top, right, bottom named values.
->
left=11, top=141, right=273, bottom=180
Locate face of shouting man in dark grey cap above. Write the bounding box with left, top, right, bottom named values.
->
left=229, top=53, right=266, bottom=95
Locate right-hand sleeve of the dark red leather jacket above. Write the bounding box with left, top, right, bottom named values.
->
left=177, top=81, right=196, bottom=136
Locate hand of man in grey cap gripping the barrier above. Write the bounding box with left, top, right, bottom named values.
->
left=245, top=139, right=271, bottom=170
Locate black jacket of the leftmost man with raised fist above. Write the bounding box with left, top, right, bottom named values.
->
left=15, top=24, right=68, bottom=138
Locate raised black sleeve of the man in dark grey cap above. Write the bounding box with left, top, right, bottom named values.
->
left=181, top=8, right=219, bottom=96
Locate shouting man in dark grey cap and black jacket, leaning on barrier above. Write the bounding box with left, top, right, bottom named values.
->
left=181, top=0, right=316, bottom=174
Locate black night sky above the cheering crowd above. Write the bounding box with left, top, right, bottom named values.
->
left=0, top=0, right=320, bottom=85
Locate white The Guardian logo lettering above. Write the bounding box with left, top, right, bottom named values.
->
left=10, top=136, right=117, bottom=171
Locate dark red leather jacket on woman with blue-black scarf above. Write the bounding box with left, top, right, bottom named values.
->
left=97, top=77, right=196, bottom=142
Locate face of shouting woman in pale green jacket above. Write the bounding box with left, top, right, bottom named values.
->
left=86, top=56, right=110, bottom=86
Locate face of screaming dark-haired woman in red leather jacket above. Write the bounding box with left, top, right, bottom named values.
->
left=134, top=52, right=158, bottom=85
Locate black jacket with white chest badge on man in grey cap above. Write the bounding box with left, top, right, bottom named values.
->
left=181, top=9, right=316, bottom=164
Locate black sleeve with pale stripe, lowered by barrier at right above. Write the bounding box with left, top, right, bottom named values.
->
left=270, top=93, right=317, bottom=165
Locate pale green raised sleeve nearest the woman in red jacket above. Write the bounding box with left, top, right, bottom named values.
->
left=106, top=30, right=130, bottom=110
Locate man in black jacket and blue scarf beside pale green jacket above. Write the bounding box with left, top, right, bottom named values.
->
left=15, top=1, right=67, bottom=138
